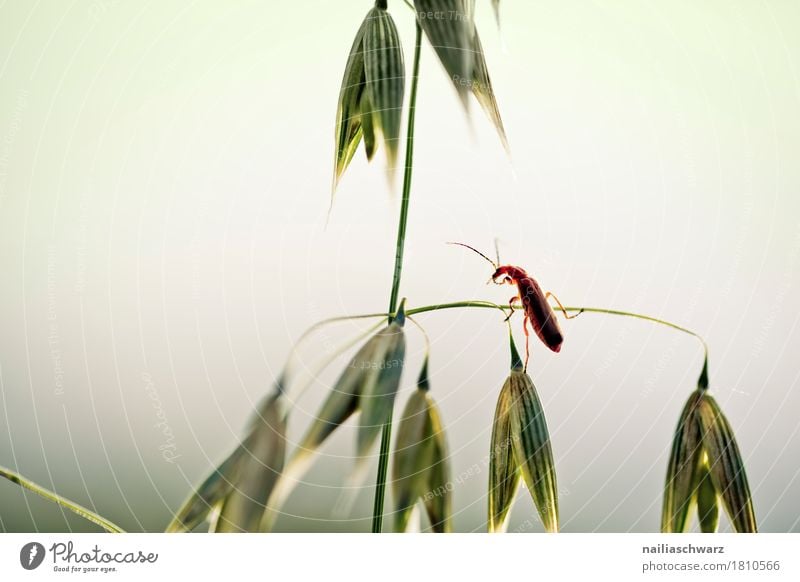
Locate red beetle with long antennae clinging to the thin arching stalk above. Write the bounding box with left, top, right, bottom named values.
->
left=448, top=242, right=583, bottom=369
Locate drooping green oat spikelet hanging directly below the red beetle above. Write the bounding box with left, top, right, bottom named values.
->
left=489, top=337, right=559, bottom=532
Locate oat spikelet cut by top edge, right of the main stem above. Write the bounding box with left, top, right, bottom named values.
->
left=414, top=0, right=509, bottom=151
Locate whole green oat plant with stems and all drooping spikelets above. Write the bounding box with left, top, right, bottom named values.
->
left=0, top=0, right=756, bottom=532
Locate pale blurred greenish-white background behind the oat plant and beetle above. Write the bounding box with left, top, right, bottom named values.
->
left=0, top=0, right=800, bottom=532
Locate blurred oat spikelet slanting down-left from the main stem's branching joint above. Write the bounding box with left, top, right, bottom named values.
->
left=260, top=303, right=406, bottom=531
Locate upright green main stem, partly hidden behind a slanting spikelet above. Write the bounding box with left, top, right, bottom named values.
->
left=372, top=19, right=422, bottom=533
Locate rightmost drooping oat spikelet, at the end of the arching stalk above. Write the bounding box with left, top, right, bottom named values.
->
left=661, top=386, right=757, bottom=533
